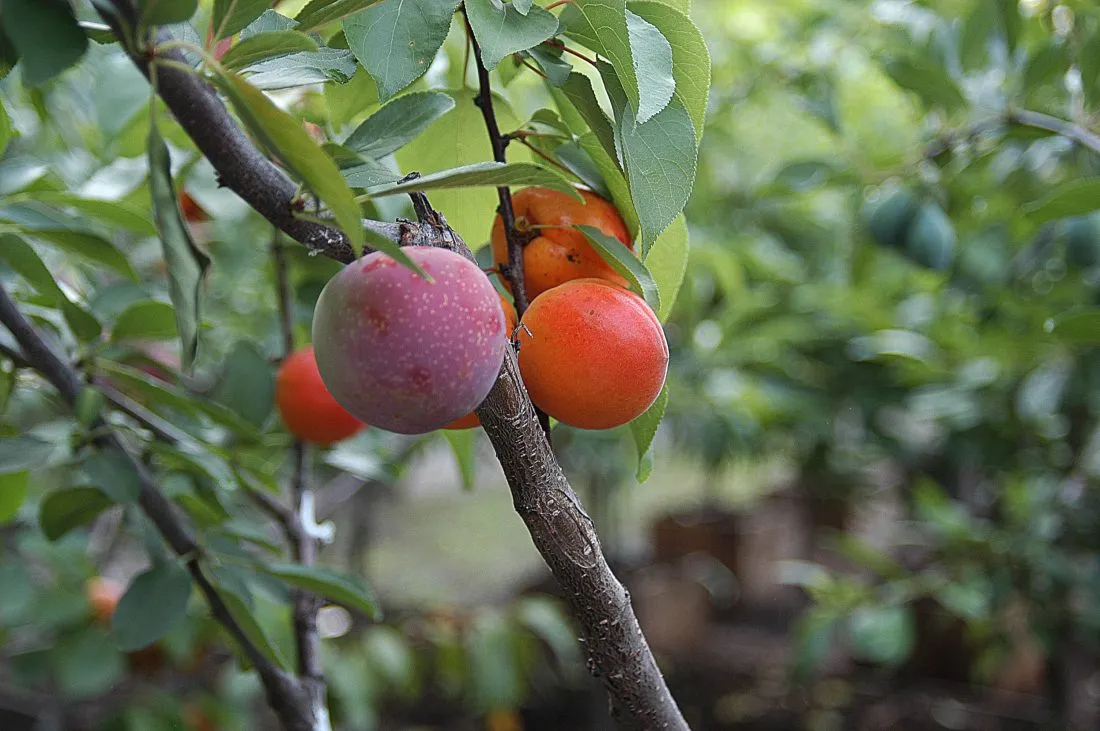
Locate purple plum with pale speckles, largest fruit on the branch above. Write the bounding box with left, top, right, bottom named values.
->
left=314, top=246, right=507, bottom=434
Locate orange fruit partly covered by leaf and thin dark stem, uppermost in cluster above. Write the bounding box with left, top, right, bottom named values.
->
left=492, top=188, right=634, bottom=300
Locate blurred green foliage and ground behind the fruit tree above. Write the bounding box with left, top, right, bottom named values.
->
left=0, top=0, right=1100, bottom=731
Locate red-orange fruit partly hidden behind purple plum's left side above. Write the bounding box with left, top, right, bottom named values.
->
left=275, top=347, right=363, bottom=444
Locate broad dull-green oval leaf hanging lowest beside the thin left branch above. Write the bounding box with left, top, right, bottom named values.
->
left=111, top=562, right=191, bottom=651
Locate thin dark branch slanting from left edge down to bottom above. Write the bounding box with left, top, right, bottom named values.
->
left=0, top=286, right=315, bottom=731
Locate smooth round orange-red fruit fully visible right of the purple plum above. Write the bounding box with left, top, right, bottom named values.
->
left=517, top=279, right=669, bottom=429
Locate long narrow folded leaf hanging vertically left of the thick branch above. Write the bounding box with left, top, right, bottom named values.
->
left=149, top=120, right=206, bottom=370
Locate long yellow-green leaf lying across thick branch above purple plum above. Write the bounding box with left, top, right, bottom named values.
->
left=211, top=67, right=369, bottom=261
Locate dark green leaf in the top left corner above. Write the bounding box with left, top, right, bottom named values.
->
left=0, top=0, right=88, bottom=86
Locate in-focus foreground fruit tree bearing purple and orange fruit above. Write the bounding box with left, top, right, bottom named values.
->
left=0, top=0, right=708, bottom=731
